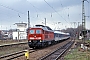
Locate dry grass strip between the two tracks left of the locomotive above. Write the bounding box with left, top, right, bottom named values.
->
left=0, top=44, right=28, bottom=56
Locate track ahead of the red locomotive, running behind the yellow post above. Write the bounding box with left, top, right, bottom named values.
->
left=0, top=49, right=36, bottom=60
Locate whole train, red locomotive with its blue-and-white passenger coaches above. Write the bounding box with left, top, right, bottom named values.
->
left=27, top=25, right=70, bottom=48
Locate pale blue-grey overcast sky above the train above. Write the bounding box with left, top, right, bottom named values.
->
left=0, top=0, right=90, bottom=30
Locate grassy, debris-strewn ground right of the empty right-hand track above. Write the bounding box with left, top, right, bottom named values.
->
left=64, top=40, right=90, bottom=60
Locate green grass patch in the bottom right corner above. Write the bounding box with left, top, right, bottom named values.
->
left=64, top=48, right=90, bottom=60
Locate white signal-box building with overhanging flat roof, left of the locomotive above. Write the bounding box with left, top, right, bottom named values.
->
left=12, top=23, right=27, bottom=40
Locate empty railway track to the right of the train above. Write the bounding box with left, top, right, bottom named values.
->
left=38, top=41, right=74, bottom=60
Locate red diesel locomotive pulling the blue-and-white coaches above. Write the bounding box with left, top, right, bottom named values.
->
left=27, top=25, right=54, bottom=48
